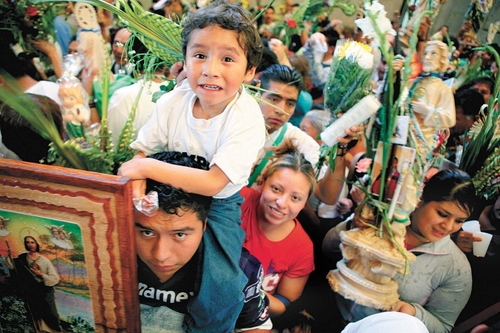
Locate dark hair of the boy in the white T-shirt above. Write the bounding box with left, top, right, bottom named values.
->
left=181, top=0, right=264, bottom=70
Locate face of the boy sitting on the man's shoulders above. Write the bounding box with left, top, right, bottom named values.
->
left=184, top=26, right=255, bottom=114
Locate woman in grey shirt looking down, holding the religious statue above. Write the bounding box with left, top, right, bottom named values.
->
left=323, top=170, right=476, bottom=332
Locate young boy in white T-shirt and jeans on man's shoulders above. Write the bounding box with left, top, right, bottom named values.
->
left=119, top=2, right=265, bottom=333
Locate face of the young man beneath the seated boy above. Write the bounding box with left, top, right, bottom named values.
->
left=134, top=209, right=205, bottom=282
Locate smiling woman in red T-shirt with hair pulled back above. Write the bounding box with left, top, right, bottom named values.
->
left=241, top=140, right=316, bottom=316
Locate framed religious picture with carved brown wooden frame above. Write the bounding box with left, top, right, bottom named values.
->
left=0, top=159, right=140, bottom=332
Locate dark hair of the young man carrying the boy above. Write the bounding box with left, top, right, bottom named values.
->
left=146, top=151, right=212, bottom=222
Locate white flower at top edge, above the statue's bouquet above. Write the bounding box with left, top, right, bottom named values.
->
left=354, top=1, right=396, bottom=47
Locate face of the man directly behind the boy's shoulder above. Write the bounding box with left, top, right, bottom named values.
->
left=259, top=81, right=299, bottom=134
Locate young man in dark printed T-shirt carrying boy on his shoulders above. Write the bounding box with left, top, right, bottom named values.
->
left=134, top=152, right=272, bottom=332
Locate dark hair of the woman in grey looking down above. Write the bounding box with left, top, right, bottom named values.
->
left=422, top=169, right=477, bottom=215
